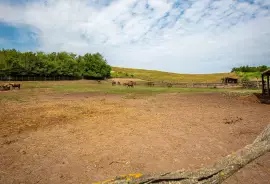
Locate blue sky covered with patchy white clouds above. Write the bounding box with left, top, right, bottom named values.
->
left=0, top=0, right=270, bottom=73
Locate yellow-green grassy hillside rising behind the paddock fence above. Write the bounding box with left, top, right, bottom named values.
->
left=112, top=67, right=237, bottom=82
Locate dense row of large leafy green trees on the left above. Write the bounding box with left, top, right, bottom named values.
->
left=0, top=49, right=111, bottom=79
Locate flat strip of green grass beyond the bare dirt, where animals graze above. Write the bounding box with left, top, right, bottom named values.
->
left=0, top=80, right=260, bottom=101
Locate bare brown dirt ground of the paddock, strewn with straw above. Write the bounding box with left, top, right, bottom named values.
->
left=0, top=93, right=270, bottom=184
